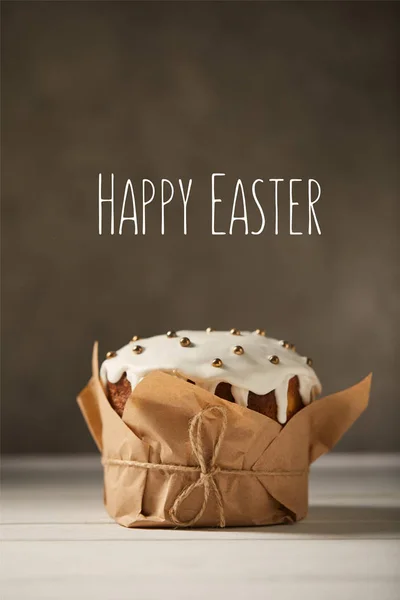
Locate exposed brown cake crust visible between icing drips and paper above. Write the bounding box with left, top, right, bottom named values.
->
left=107, top=373, right=304, bottom=421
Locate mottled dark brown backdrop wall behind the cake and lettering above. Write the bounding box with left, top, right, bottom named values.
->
left=2, top=2, right=400, bottom=453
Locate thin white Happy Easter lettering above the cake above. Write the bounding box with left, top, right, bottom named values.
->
left=98, top=173, right=321, bottom=236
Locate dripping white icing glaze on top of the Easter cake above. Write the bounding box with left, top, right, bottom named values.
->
left=100, top=331, right=321, bottom=424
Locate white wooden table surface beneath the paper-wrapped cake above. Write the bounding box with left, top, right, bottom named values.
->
left=0, top=454, right=400, bottom=600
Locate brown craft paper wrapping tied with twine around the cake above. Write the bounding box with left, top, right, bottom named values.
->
left=78, top=344, right=371, bottom=527
